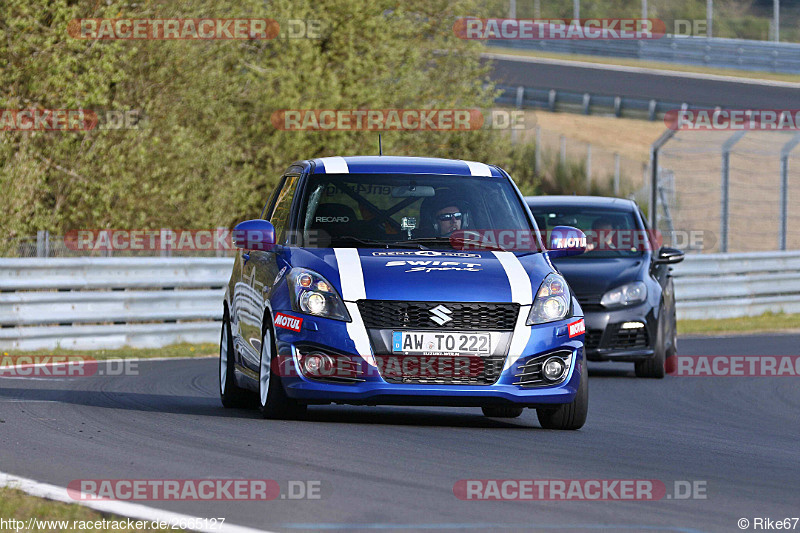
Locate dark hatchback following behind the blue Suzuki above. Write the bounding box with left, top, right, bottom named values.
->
left=525, top=196, right=684, bottom=378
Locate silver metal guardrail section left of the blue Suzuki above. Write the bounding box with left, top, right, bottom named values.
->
left=0, top=257, right=233, bottom=350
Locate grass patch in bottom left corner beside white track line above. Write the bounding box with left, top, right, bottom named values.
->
left=0, top=488, right=166, bottom=533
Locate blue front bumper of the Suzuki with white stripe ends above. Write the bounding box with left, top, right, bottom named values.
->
left=276, top=310, right=585, bottom=407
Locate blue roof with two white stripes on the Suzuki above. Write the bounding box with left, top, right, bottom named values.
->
left=310, top=156, right=503, bottom=178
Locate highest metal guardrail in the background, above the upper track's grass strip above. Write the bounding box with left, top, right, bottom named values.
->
left=488, top=35, right=800, bottom=74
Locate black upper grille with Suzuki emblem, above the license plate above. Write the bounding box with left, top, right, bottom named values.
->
left=358, top=300, right=519, bottom=331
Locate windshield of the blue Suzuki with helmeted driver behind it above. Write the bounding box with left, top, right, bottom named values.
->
left=300, top=174, right=540, bottom=251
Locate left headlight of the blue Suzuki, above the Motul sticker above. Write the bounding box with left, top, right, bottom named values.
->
left=286, top=268, right=350, bottom=322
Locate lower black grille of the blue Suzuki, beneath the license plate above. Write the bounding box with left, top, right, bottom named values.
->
left=375, top=355, right=506, bottom=385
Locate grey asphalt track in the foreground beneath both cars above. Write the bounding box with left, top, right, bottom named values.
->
left=0, top=334, right=800, bottom=531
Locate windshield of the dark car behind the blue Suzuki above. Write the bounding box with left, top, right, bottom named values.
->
left=531, top=205, right=650, bottom=259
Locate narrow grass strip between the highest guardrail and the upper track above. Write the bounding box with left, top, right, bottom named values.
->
left=485, top=46, right=800, bottom=83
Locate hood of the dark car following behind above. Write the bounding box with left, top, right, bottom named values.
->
left=553, top=257, right=647, bottom=298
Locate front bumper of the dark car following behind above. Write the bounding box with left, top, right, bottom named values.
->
left=584, top=302, right=658, bottom=362
